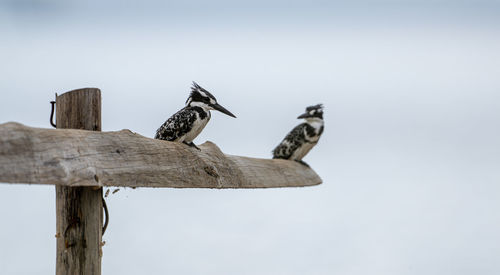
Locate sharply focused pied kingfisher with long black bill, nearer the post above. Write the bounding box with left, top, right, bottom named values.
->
left=155, top=81, right=236, bottom=150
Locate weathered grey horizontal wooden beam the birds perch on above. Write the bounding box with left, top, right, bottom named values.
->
left=0, top=122, right=321, bottom=188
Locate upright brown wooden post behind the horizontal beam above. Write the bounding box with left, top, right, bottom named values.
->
left=56, top=88, right=102, bottom=275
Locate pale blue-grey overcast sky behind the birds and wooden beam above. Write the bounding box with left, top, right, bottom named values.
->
left=0, top=0, right=500, bottom=275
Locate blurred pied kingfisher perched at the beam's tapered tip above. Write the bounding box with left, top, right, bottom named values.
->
left=273, top=104, right=324, bottom=166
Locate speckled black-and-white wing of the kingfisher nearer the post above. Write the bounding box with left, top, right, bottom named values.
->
left=155, top=107, right=196, bottom=141
